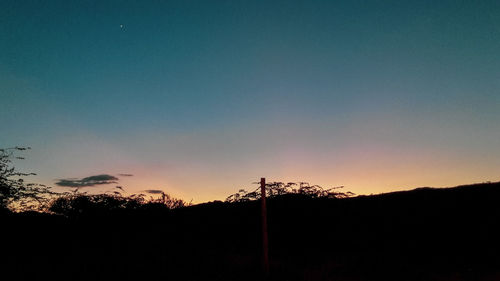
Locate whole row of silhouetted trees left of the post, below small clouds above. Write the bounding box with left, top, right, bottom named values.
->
left=0, top=146, right=190, bottom=213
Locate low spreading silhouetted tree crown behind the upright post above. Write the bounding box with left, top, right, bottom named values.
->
left=226, top=182, right=355, bottom=202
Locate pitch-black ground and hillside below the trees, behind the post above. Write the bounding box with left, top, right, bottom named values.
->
left=0, top=180, right=500, bottom=281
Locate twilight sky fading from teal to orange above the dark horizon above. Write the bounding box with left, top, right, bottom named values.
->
left=0, top=0, right=500, bottom=202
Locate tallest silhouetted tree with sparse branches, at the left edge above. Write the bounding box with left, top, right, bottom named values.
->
left=0, top=147, right=57, bottom=211
